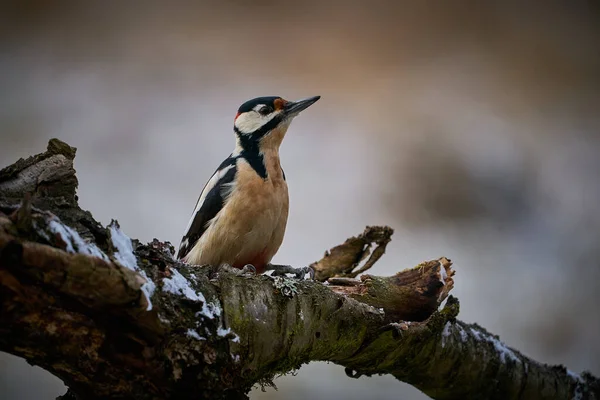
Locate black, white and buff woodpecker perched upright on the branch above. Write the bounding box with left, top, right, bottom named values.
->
left=177, top=96, right=321, bottom=276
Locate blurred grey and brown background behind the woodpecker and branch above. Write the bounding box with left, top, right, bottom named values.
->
left=0, top=0, right=600, bottom=400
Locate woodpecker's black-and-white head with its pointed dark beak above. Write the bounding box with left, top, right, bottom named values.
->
left=233, top=96, right=321, bottom=148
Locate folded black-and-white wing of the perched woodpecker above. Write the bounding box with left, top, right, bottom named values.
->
left=177, top=156, right=237, bottom=259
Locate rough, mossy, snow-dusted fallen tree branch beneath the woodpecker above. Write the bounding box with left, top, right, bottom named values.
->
left=0, top=140, right=600, bottom=400
